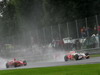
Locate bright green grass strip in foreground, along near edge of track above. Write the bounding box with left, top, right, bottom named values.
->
left=0, top=64, right=100, bottom=75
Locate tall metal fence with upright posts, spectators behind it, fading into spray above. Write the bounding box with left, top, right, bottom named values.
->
left=1, top=15, right=100, bottom=50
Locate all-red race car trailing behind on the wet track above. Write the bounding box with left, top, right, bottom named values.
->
left=6, top=59, right=27, bottom=68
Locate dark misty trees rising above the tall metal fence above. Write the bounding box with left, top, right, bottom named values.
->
left=0, top=0, right=100, bottom=43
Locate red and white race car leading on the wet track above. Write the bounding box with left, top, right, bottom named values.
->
left=64, top=51, right=90, bottom=61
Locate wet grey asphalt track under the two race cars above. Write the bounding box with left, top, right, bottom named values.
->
left=0, top=57, right=100, bottom=70
